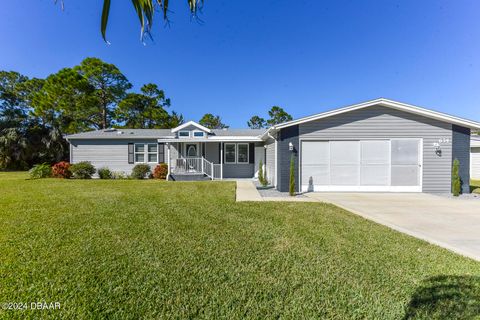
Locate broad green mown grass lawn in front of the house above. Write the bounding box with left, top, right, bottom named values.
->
left=0, top=173, right=480, bottom=319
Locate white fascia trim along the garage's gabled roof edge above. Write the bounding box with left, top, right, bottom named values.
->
left=273, top=98, right=480, bottom=129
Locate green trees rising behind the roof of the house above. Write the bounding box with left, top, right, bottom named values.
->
left=0, top=58, right=291, bottom=170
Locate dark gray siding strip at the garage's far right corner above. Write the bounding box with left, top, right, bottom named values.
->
left=452, top=125, right=470, bottom=193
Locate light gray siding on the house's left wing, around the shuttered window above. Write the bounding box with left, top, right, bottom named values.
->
left=70, top=139, right=166, bottom=174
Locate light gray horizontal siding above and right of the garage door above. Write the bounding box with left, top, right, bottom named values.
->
left=300, top=106, right=452, bottom=193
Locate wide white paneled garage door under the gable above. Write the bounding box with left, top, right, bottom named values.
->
left=301, top=139, right=421, bottom=192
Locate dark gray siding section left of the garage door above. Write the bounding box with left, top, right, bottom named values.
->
left=277, top=125, right=300, bottom=192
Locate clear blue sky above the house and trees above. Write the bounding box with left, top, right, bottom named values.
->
left=0, top=0, right=480, bottom=127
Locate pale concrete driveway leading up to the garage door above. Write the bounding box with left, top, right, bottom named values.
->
left=306, top=193, right=480, bottom=261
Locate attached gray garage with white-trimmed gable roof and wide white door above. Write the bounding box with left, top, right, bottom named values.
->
left=266, top=99, right=480, bottom=193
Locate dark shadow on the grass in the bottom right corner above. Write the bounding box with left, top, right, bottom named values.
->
left=404, top=276, right=480, bottom=320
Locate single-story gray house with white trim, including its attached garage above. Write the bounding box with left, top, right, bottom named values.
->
left=67, top=98, right=480, bottom=193
